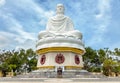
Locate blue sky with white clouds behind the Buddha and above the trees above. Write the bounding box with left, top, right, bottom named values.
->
left=0, top=0, right=120, bottom=49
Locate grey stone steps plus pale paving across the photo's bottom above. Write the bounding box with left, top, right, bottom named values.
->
left=0, top=72, right=120, bottom=83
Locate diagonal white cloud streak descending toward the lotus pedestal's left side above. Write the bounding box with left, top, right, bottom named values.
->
left=2, top=14, right=35, bottom=40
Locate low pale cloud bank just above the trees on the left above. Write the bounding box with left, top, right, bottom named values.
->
left=0, top=31, right=36, bottom=49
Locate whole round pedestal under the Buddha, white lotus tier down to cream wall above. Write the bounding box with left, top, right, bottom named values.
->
left=36, top=35, right=85, bottom=70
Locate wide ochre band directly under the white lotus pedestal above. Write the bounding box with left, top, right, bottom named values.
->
left=36, top=47, right=85, bottom=55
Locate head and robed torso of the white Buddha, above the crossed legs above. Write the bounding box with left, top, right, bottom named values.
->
left=46, top=4, right=74, bottom=33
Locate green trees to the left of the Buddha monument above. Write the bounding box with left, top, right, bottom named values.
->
left=0, top=49, right=37, bottom=74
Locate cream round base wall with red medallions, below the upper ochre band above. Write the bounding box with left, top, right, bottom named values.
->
left=37, top=52, right=83, bottom=72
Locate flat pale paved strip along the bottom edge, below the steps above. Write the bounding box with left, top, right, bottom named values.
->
left=0, top=77, right=120, bottom=83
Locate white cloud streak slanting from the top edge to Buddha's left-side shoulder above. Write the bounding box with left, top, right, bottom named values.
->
left=11, top=0, right=55, bottom=24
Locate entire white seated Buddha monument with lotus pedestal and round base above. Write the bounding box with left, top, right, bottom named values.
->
left=36, top=4, right=85, bottom=70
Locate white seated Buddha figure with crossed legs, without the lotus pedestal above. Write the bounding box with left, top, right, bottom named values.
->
left=39, top=4, right=82, bottom=39
